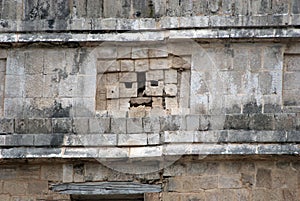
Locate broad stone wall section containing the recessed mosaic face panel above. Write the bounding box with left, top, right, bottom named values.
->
left=0, top=41, right=300, bottom=118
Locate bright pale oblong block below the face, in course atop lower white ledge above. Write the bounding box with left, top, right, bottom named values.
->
left=118, top=133, right=147, bottom=146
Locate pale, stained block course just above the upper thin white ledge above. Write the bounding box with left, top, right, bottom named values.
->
left=0, top=14, right=300, bottom=33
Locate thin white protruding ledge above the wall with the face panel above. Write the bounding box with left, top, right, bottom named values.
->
left=0, top=27, right=300, bottom=43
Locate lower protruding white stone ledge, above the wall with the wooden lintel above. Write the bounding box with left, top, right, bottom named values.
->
left=0, top=143, right=300, bottom=160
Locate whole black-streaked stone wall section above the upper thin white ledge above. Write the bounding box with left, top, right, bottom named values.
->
left=0, top=0, right=300, bottom=32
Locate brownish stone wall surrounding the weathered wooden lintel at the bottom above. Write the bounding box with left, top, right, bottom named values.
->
left=0, top=156, right=300, bottom=201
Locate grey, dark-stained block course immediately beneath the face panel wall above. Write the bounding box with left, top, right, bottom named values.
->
left=0, top=113, right=300, bottom=134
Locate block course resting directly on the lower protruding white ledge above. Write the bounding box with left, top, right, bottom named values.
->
left=0, top=130, right=300, bottom=149
